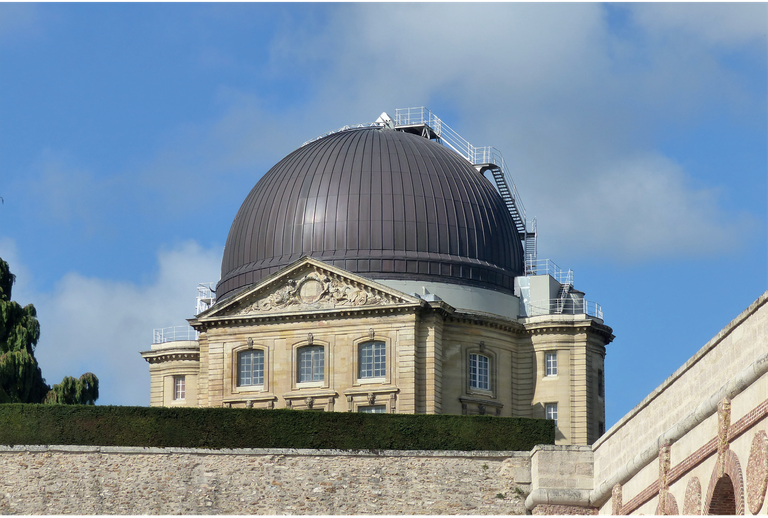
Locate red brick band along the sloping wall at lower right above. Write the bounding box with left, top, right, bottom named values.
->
left=621, top=401, right=768, bottom=516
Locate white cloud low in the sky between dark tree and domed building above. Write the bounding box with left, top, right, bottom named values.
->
left=18, top=242, right=221, bottom=405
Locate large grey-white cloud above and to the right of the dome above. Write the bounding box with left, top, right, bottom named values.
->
left=260, top=3, right=765, bottom=260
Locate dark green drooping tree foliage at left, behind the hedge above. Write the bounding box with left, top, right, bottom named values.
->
left=0, top=258, right=99, bottom=405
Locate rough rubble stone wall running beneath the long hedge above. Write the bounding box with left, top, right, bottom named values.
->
left=0, top=446, right=531, bottom=516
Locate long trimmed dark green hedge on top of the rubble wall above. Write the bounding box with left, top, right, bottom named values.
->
left=0, top=404, right=555, bottom=451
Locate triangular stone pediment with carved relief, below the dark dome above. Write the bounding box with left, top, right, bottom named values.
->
left=196, top=257, right=422, bottom=321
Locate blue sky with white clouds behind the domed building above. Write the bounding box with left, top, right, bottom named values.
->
left=0, top=2, right=768, bottom=426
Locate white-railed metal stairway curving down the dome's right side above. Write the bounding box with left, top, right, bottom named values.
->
left=393, top=106, right=537, bottom=266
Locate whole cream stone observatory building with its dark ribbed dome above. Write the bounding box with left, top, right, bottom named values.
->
left=142, top=118, right=613, bottom=444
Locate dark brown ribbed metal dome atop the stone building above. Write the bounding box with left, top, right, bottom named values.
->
left=216, top=127, right=524, bottom=300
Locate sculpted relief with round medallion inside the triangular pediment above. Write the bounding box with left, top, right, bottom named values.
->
left=236, top=272, right=392, bottom=315
